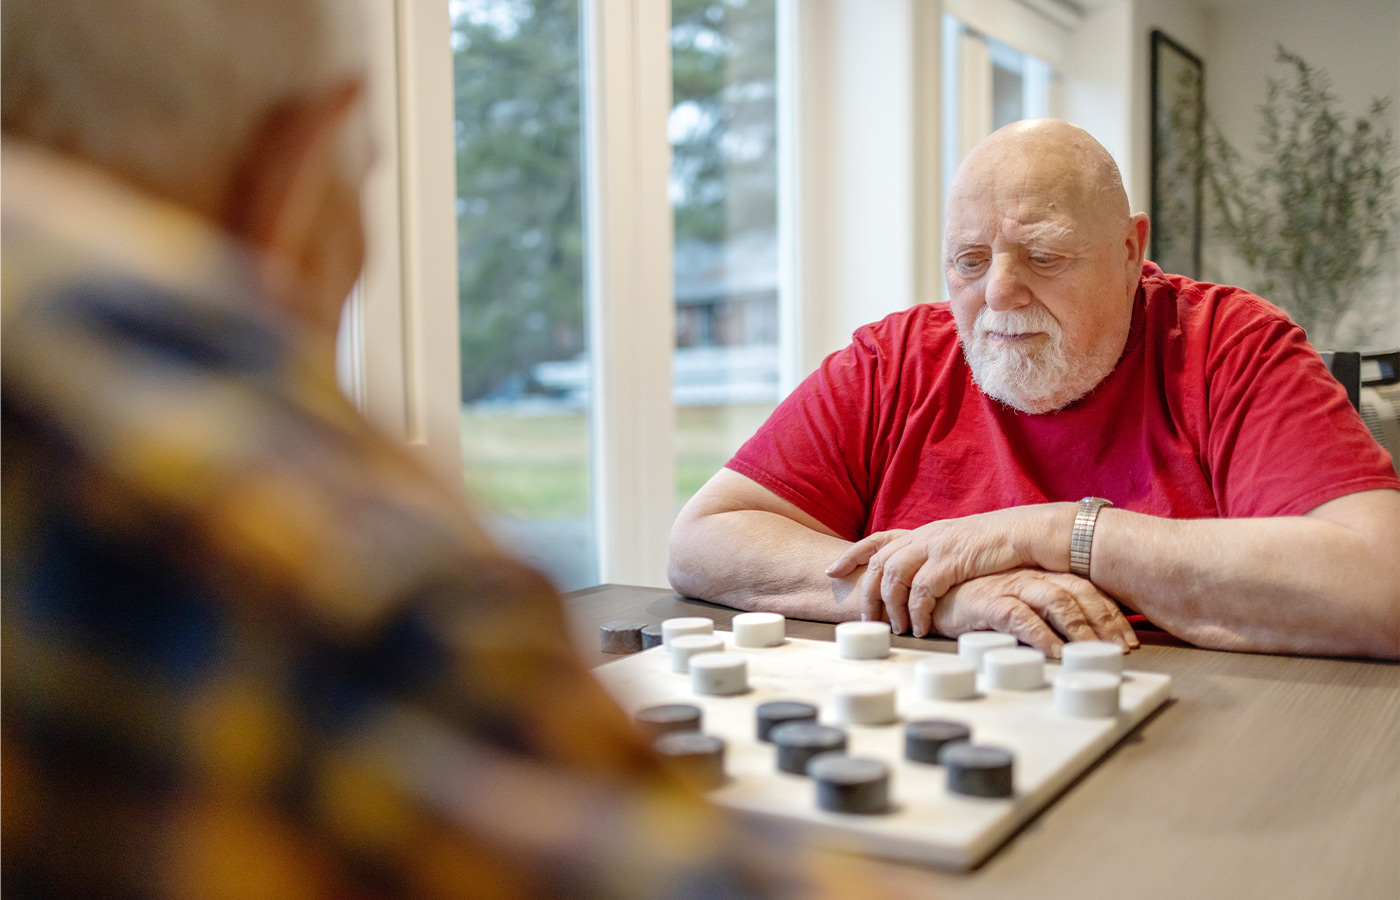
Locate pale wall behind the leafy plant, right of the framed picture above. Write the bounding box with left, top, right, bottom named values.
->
left=1205, top=0, right=1400, bottom=349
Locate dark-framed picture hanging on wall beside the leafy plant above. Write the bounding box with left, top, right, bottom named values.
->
left=1148, top=31, right=1205, bottom=279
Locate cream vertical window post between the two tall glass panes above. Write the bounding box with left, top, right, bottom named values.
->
left=584, top=0, right=675, bottom=585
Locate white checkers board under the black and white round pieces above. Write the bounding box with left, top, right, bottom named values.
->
left=595, top=631, right=1172, bottom=869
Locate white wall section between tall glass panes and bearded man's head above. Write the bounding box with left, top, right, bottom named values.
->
left=792, top=0, right=941, bottom=378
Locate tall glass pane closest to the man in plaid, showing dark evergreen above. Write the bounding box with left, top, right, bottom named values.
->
left=451, top=0, right=598, bottom=591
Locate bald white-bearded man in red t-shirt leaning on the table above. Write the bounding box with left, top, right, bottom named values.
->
left=671, top=120, right=1400, bottom=658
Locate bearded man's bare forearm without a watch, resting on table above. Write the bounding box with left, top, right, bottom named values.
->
left=668, top=509, right=865, bottom=621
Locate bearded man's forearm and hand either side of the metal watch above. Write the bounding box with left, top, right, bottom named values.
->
left=833, top=490, right=1400, bottom=659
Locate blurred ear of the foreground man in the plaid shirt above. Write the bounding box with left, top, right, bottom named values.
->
left=221, top=81, right=364, bottom=274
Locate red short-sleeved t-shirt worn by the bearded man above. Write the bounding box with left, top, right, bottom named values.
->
left=728, top=263, right=1400, bottom=540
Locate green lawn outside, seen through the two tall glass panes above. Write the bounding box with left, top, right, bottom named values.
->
left=462, top=405, right=773, bottom=519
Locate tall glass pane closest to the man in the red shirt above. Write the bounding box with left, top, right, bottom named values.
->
left=668, top=0, right=778, bottom=508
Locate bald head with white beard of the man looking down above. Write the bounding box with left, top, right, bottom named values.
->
left=944, top=119, right=1148, bottom=414
